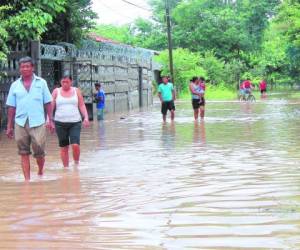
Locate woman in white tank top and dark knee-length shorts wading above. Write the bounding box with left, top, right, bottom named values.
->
left=52, top=73, right=89, bottom=167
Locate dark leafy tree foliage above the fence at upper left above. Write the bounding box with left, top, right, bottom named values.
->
left=0, top=0, right=96, bottom=59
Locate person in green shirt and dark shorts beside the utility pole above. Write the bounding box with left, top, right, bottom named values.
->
left=158, top=76, right=176, bottom=122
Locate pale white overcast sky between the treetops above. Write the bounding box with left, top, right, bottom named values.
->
left=93, top=0, right=151, bottom=25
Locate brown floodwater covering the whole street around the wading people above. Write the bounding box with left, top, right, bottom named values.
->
left=0, top=96, right=300, bottom=250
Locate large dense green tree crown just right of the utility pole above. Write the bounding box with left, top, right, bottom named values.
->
left=173, top=0, right=278, bottom=57
